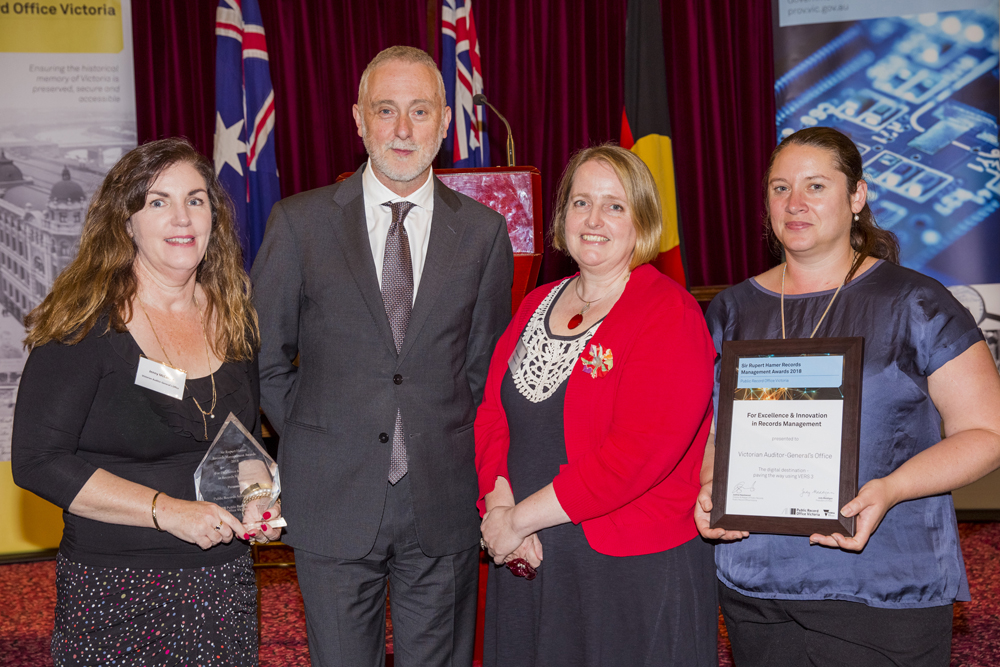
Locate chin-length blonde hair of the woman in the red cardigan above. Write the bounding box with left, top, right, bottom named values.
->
left=549, top=144, right=663, bottom=270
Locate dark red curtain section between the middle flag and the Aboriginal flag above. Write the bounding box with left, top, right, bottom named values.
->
left=474, top=0, right=625, bottom=283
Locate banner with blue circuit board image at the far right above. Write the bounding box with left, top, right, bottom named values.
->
left=773, top=0, right=1000, bottom=365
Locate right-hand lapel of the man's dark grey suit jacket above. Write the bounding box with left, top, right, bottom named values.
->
left=394, top=176, right=466, bottom=362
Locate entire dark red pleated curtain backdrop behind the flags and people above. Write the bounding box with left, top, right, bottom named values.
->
left=132, top=0, right=774, bottom=285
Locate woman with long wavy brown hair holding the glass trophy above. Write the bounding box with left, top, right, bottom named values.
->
left=12, top=139, right=279, bottom=665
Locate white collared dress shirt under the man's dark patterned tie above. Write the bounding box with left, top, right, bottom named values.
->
left=361, top=159, right=434, bottom=301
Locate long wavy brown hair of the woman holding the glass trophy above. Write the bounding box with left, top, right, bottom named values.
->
left=24, top=138, right=260, bottom=361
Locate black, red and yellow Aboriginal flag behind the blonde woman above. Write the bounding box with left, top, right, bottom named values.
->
left=621, top=0, right=687, bottom=286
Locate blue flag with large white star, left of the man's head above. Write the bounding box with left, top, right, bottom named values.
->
left=215, top=0, right=281, bottom=270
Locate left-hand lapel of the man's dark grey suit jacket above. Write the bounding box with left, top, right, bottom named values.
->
left=332, top=166, right=396, bottom=355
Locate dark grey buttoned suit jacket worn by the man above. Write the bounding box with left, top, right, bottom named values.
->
left=252, top=167, right=513, bottom=558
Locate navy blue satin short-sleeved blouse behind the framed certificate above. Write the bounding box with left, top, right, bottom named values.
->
left=707, top=262, right=983, bottom=608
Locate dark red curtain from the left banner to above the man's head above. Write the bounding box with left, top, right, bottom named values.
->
left=132, top=0, right=427, bottom=197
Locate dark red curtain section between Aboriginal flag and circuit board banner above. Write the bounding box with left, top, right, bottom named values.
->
left=663, top=0, right=777, bottom=285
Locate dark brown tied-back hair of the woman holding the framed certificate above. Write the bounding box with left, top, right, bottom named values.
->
left=764, top=127, right=899, bottom=281
